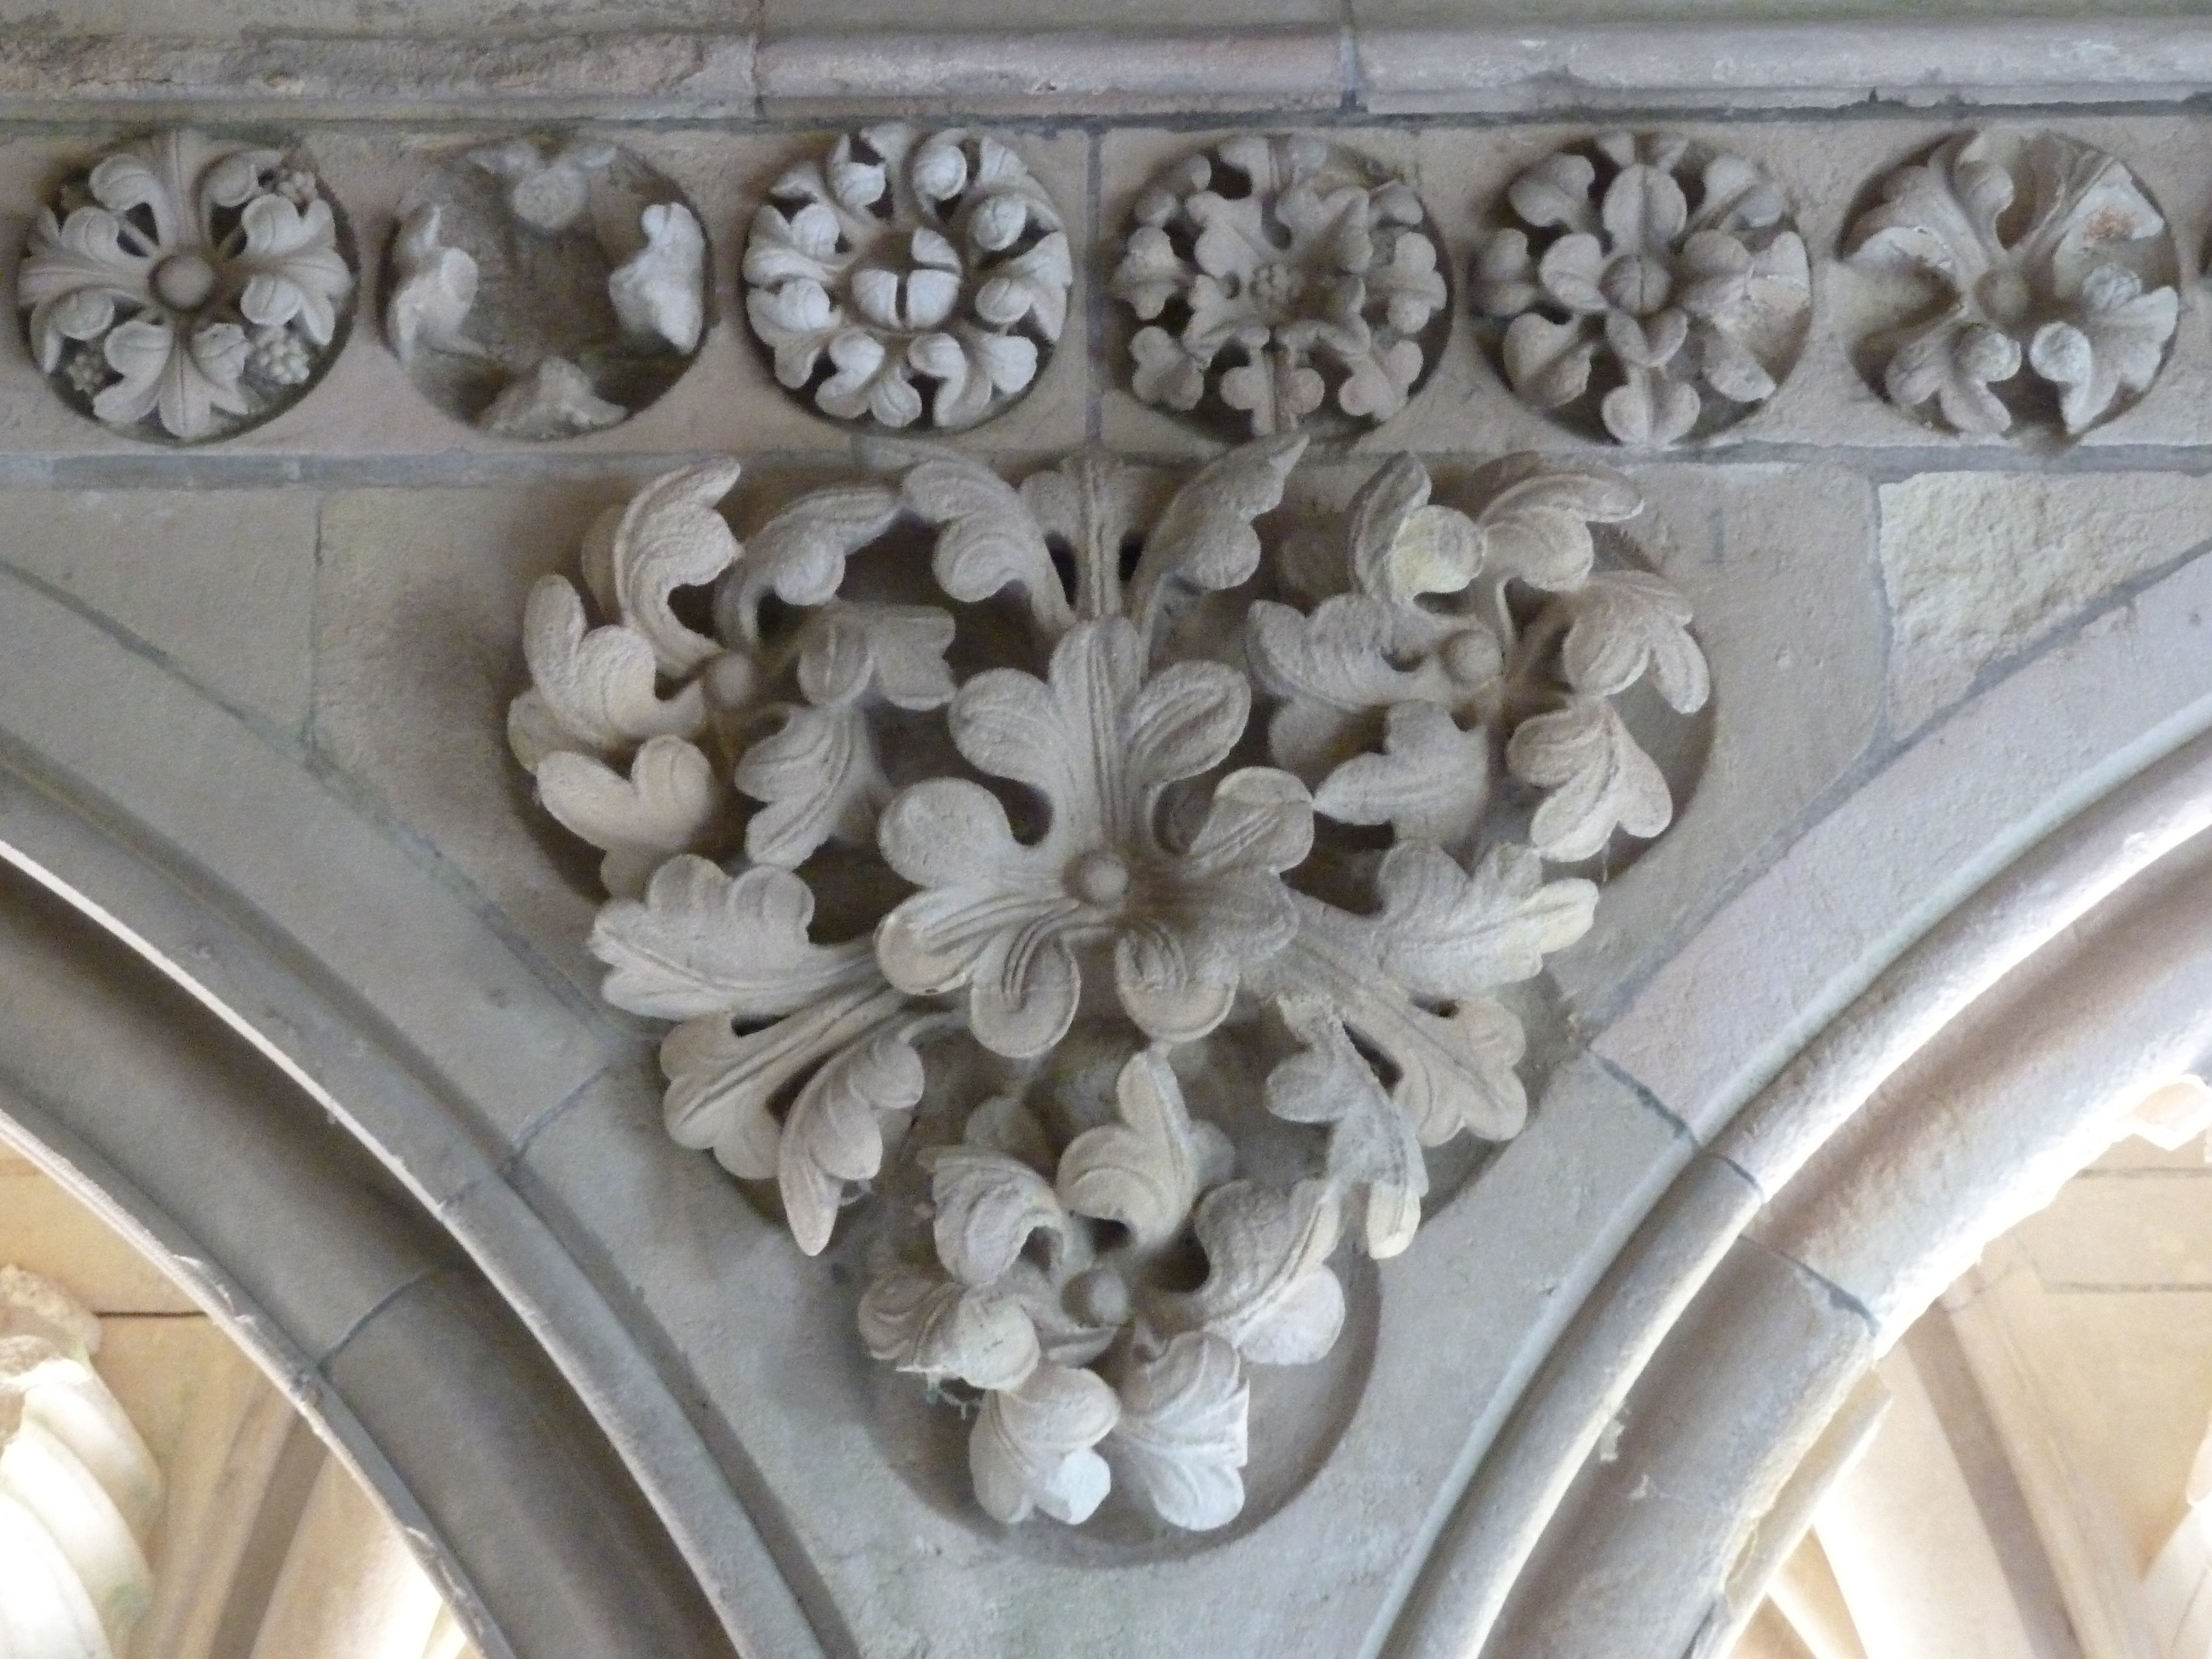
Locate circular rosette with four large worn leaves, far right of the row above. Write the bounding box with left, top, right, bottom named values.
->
left=1845, top=133, right=2181, bottom=438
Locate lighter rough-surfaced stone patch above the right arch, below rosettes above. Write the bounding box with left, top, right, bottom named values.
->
left=1878, top=473, right=2212, bottom=734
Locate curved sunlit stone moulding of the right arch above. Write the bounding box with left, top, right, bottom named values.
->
left=1385, top=672, right=2212, bottom=1659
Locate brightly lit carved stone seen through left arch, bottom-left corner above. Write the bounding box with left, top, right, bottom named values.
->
left=0, top=1267, right=161, bottom=1659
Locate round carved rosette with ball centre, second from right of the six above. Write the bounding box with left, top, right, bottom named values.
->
left=1475, top=133, right=1812, bottom=445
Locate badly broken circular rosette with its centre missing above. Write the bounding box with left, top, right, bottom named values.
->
left=385, top=135, right=708, bottom=440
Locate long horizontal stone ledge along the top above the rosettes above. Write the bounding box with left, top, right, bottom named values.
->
left=13, top=15, right=2212, bottom=122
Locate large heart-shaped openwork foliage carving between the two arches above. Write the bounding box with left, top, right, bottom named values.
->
left=509, top=436, right=1708, bottom=1528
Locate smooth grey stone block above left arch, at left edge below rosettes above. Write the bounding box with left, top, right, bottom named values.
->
left=0, top=489, right=319, bottom=732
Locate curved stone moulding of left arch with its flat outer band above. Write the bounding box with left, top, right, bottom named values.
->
left=0, top=562, right=805, bottom=1659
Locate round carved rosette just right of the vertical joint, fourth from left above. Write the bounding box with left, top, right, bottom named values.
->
left=1110, top=135, right=1451, bottom=436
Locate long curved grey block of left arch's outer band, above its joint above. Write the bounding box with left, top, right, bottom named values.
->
left=0, top=571, right=604, bottom=1150
